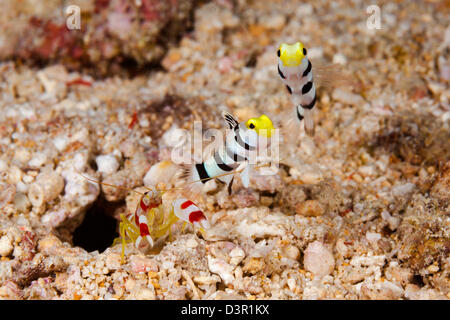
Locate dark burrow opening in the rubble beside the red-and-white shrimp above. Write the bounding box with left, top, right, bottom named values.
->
left=73, top=197, right=124, bottom=252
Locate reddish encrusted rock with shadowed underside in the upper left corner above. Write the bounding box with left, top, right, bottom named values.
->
left=0, top=0, right=197, bottom=76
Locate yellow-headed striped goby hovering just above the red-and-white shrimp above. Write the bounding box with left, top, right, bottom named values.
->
left=185, top=113, right=274, bottom=192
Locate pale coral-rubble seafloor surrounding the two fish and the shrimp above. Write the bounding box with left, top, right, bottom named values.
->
left=0, top=0, right=450, bottom=299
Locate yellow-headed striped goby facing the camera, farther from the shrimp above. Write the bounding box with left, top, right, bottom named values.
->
left=277, top=42, right=316, bottom=136
